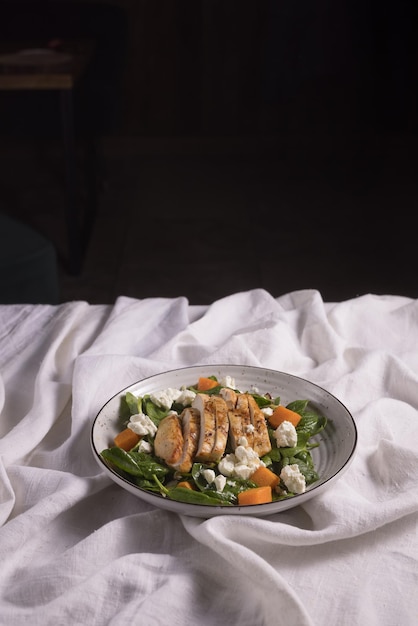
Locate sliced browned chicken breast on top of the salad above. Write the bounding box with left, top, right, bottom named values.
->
left=154, top=388, right=271, bottom=474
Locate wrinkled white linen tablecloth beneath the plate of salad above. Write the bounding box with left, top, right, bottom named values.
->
left=0, top=289, right=418, bottom=626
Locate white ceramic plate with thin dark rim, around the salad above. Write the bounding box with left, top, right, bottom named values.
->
left=91, top=365, right=357, bottom=518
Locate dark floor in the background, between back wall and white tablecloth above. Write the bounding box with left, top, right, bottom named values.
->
left=0, top=134, right=418, bottom=304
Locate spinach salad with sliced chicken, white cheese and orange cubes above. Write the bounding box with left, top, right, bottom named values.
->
left=101, top=376, right=327, bottom=506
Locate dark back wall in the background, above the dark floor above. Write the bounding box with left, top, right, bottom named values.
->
left=0, top=0, right=418, bottom=137
